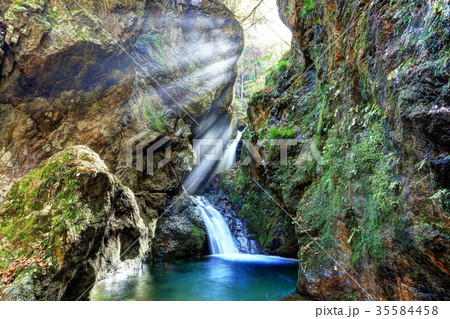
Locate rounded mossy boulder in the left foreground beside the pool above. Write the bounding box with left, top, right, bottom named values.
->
left=0, top=146, right=149, bottom=300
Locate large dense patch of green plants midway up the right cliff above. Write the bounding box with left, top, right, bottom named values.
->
left=298, top=100, right=401, bottom=270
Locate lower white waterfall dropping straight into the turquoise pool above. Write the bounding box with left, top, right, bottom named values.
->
left=193, top=196, right=239, bottom=255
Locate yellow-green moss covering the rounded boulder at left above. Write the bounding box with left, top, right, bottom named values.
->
left=0, top=150, right=104, bottom=268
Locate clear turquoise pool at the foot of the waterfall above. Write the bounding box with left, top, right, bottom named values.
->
left=91, top=254, right=298, bottom=301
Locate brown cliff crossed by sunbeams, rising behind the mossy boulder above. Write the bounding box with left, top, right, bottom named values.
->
left=0, top=0, right=243, bottom=299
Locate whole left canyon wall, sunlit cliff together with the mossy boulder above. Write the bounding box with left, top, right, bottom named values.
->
left=0, top=0, right=244, bottom=300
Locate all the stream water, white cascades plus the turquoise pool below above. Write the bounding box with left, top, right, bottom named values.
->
left=91, top=125, right=298, bottom=301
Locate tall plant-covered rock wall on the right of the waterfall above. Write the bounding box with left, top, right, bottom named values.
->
left=224, top=0, right=450, bottom=300
